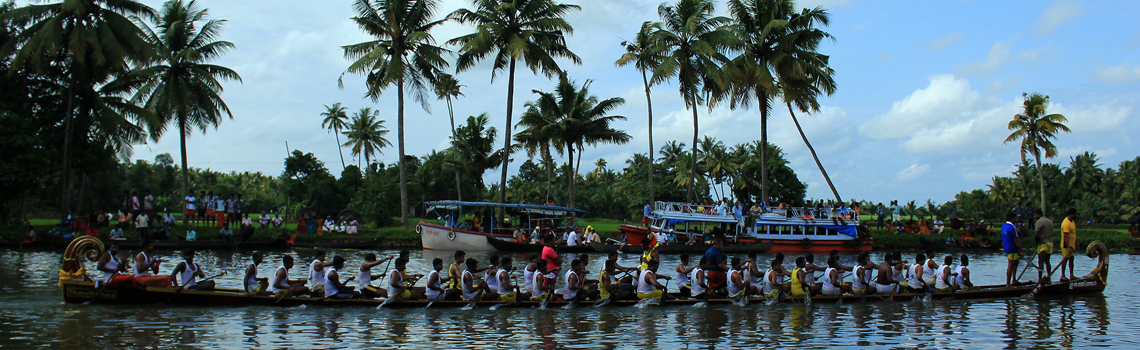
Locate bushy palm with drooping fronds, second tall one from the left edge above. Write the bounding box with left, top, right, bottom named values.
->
left=135, top=0, right=242, bottom=218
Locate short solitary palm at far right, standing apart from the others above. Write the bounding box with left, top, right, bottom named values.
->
left=1002, top=92, right=1070, bottom=212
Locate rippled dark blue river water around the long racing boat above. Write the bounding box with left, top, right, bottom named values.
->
left=0, top=250, right=1140, bottom=349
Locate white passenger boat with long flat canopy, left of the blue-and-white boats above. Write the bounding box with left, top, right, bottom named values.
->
left=416, top=201, right=586, bottom=252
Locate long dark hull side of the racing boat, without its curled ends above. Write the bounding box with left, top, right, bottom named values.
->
left=62, top=280, right=1035, bottom=308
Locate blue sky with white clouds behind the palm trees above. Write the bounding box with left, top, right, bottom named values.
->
left=102, top=0, right=1140, bottom=203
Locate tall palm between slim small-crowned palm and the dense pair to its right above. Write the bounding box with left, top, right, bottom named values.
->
left=653, top=0, right=738, bottom=202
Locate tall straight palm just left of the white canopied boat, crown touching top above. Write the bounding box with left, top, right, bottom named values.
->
left=342, top=0, right=448, bottom=228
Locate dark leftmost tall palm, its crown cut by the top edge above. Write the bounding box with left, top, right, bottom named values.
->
left=0, top=0, right=155, bottom=217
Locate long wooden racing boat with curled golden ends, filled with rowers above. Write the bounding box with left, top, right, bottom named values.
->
left=59, top=237, right=1108, bottom=308
